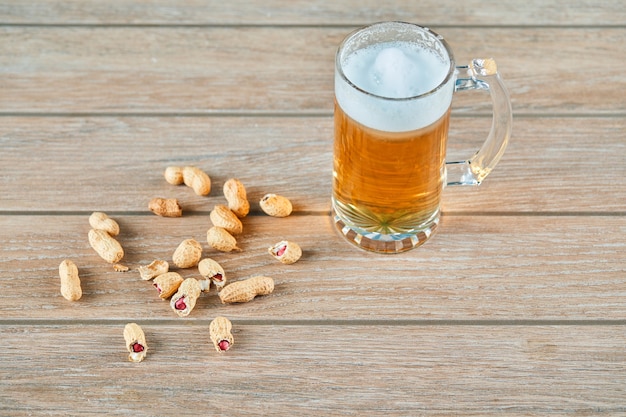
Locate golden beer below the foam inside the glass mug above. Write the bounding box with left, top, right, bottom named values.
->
left=333, top=102, right=450, bottom=235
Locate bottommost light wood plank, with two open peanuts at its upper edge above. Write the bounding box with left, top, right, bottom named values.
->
left=0, top=321, right=626, bottom=416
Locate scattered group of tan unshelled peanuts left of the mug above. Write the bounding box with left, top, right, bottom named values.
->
left=59, top=167, right=302, bottom=362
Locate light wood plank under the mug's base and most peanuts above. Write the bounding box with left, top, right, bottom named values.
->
left=0, top=214, right=626, bottom=322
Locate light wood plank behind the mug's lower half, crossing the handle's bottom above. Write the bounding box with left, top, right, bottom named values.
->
left=0, top=116, right=626, bottom=213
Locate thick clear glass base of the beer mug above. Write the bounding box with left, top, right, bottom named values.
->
left=332, top=199, right=440, bottom=254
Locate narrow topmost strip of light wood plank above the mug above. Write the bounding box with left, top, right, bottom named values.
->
left=0, top=0, right=626, bottom=26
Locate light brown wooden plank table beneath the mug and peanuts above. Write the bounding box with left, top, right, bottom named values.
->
left=0, top=0, right=626, bottom=416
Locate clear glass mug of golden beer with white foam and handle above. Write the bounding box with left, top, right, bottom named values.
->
left=332, top=22, right=512, bottom=253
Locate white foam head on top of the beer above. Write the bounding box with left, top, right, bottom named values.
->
left=335, top=41, right=455, bottom=132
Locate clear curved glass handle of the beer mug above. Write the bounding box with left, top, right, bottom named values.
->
left=446, top=59, right=513, bottom=185
